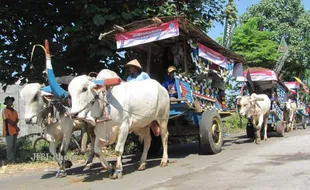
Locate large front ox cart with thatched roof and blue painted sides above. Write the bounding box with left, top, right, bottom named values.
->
left=99, top=17, right=244, bottom=154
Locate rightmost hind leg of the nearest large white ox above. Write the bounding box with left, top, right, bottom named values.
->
left=159, top=121, right=169, bottom=167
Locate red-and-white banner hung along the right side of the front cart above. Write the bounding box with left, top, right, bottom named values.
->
left=198, top=44, right=228, bottom=69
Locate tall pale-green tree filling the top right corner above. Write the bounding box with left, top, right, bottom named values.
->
left=242, top=0, right=310, bottom=80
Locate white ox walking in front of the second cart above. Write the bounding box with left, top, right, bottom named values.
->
left=240, top=93, right=271, bottom=144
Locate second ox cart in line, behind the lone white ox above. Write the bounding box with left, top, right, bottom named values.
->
left=237, top=67, right=289, bottom=138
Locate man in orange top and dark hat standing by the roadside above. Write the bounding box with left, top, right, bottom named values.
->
left=2, top=96, right=20, bottom=161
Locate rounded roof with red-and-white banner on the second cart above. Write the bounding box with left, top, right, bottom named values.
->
left=237, top=67, right=278, bottom=82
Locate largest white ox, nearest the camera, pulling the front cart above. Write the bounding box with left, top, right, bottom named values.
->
left=68, top=75, right=170, bottom=179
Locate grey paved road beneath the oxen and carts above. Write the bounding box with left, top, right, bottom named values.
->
left=0, top=129, right=310, bottom=190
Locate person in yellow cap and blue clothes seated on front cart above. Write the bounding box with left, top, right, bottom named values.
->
left=162, top=66, right=178, bottom=98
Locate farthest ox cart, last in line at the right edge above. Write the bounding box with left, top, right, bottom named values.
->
left=284, top=82, right=308, bottom=129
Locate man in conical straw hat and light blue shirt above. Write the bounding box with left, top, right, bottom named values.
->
left=125, top=59, right=150, bottom=82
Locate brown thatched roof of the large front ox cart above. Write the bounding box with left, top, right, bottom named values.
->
left=103, top=16, right=246, bottom=63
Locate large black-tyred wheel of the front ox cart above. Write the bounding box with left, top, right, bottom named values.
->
left=199, top=110, right=223, bottom=154
